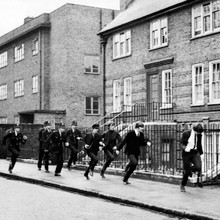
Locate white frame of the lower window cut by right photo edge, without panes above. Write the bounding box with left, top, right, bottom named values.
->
left=209, top=60, right=220, bottom=104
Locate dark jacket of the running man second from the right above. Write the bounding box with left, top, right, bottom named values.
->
left=118, top=130, right=149, bottom=156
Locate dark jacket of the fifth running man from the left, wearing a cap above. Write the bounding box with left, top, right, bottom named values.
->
left=85, top=133, right=102, bottom=154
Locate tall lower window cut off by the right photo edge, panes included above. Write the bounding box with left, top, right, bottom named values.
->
left=209, top=60, right=220, bottom=104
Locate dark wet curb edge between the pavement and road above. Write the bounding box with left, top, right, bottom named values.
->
left=0, top=172, right=213, bottom=220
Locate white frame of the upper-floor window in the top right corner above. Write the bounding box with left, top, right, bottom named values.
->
left=192, top=0, right=220, bottom=37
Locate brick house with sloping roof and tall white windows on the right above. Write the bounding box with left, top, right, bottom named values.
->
left=100, top=0, right=220, bottom=126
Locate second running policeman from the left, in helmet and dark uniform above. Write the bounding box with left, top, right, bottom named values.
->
left=42, top=121, right=52, bottom=173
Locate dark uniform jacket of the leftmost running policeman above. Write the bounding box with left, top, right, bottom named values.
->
left=6, top=131, right=26, bottom=151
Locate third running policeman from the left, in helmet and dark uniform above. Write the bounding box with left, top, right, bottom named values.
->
left=46, top=123, right=66, bottom=176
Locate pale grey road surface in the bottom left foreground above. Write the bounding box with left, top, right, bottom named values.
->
left=0, top=178, right=189, bottom=220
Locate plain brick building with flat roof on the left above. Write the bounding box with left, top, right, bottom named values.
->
left=0, top=4, right=116, bottom=126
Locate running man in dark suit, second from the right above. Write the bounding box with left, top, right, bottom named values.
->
left=118, top=122, right=151, bottom=184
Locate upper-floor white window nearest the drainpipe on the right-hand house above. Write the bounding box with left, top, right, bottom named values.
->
left=113, top=30, right=131, bottom=59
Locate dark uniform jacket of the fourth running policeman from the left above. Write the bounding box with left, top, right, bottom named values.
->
left=66, top=129, right=82, bottom=152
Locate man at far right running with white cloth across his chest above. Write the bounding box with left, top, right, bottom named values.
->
left=180, top=124, right=203, bottom=192
